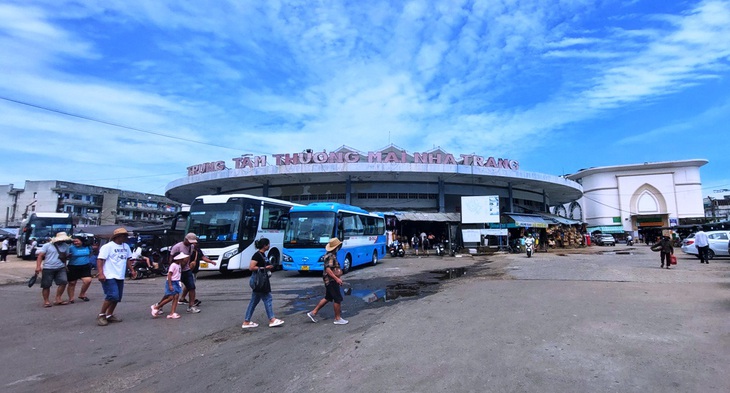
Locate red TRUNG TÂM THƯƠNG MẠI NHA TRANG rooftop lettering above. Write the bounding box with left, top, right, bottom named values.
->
left=187, top=150, right=520, bottom=176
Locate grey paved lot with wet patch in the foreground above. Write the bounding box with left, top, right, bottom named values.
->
left=0, top=245, right=730, bottom=392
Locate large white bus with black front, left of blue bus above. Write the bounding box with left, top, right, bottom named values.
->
left=186, top=194, right=297, bottom=273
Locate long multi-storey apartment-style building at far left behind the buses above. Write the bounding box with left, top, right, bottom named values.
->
left=0, top=180, right=181, bottom=227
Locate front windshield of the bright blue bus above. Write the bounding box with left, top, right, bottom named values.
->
left=284, top=212, right=335, bottom=248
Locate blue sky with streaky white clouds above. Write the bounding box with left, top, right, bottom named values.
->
left=0, top=0, right=730, bottom=199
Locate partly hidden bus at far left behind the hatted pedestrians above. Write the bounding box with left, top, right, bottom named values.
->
left=16, top=212, right=73, bottom=259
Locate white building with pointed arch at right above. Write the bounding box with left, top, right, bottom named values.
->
left=558, top=159, right=707, bottom=236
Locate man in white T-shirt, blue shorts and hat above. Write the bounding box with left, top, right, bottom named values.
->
left=96, top=228, right=137, bottom=326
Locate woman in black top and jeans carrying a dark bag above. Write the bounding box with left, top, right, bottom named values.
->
left=241, top=237, right=284, bottom=329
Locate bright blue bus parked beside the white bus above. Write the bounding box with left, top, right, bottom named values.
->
left=282, top=203, right=386, bottom=273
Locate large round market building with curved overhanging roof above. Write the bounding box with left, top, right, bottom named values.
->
left=165, top=145, right=582, bottom=245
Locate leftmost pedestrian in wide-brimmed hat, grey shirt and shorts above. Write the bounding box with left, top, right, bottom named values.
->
left=35, top=232, right=72, bottom=307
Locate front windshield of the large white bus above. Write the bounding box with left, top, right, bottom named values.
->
left=188, top=203, right=243, bottom=247
